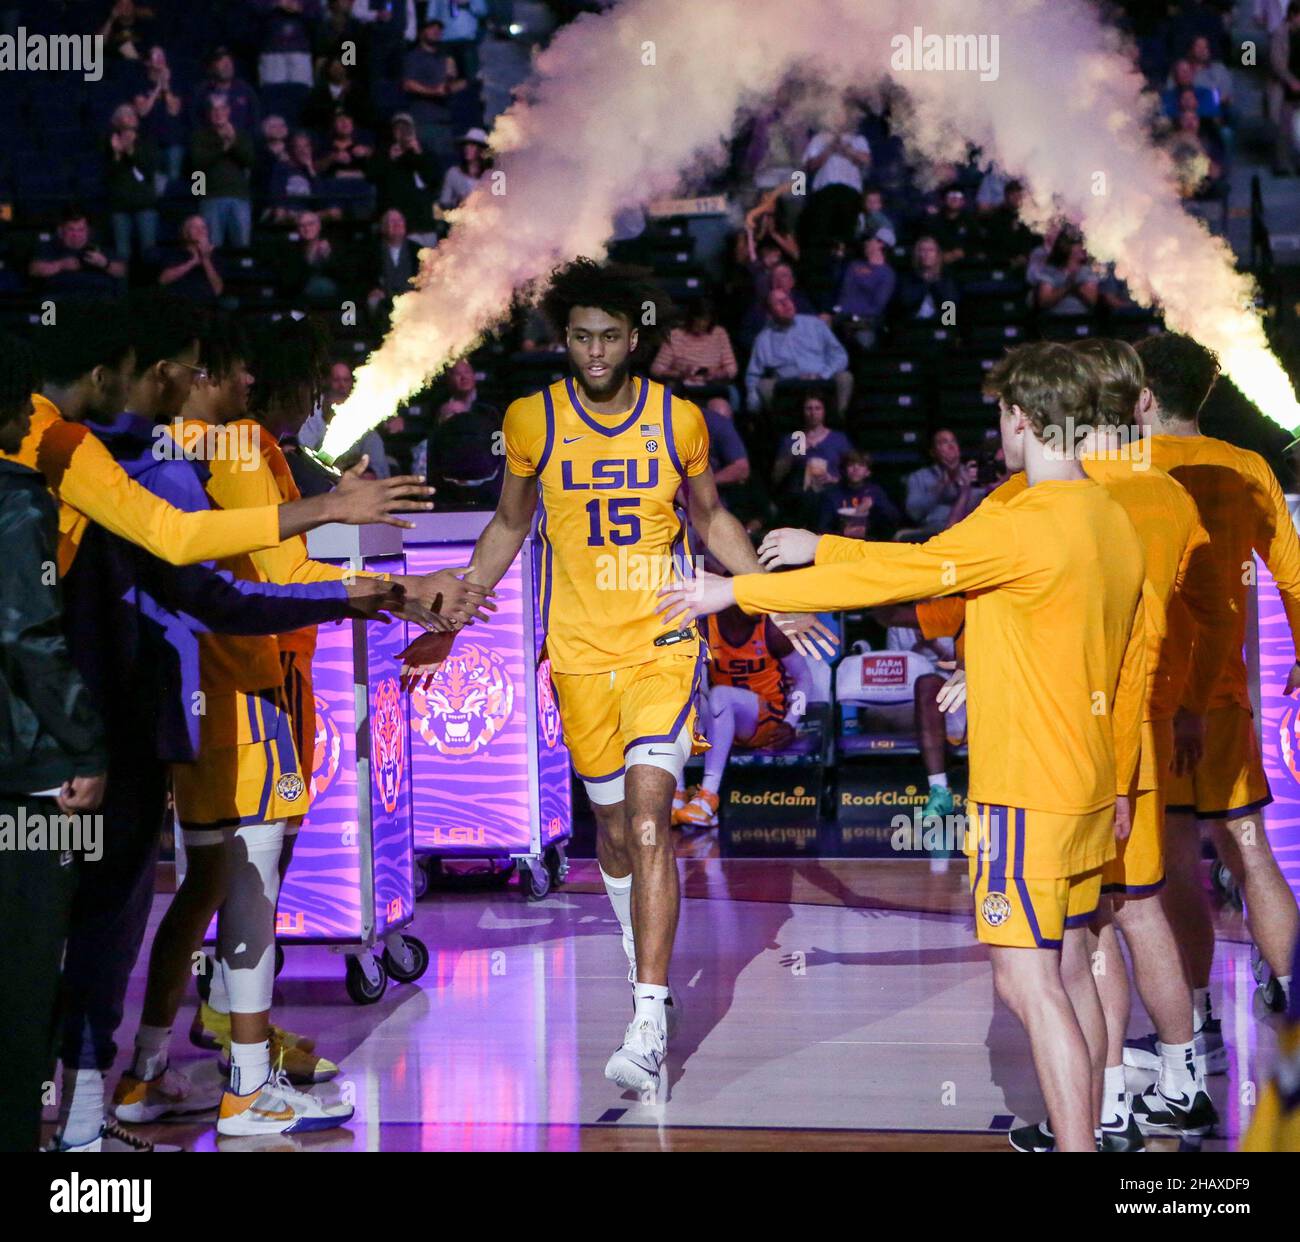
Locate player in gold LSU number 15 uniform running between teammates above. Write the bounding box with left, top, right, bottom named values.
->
left=407, top=259, right=831, bottom=1102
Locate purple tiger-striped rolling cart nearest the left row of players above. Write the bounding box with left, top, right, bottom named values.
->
left=177, top=525, right=429, bottom=1004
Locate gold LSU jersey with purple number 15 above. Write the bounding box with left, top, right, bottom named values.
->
left=506, top=377, right=709, bottom=672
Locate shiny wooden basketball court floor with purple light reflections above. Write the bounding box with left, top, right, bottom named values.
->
left=86, top=844, right=1274, bottom=1151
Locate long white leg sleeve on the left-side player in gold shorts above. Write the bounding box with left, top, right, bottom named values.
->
left=217, top=821, right=285, bottom=1013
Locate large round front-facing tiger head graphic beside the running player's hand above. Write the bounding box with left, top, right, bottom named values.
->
left=411, top=642, right=515, bottom=756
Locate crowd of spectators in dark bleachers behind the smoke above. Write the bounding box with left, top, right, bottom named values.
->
left=0, top=0, right=1235, bottom=537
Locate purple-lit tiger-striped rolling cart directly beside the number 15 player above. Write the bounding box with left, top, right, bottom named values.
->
left=404, top=512, right=572, bottom=901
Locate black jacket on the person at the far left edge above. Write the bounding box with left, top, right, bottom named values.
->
left=0, top=460, right=107, bottom=793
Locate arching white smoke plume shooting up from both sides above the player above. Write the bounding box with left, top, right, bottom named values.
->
left=324, top=0, right=1300, bottom=455
